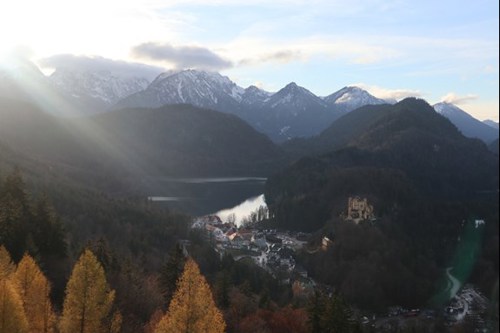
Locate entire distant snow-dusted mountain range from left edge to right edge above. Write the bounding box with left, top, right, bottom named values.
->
left=0, top=61, right=498, bottom=144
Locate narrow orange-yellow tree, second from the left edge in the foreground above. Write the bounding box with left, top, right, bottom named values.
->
left=12, top=254, right=56, bottom=333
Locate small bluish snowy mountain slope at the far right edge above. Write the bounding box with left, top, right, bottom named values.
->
left=434, top=102, right=498, bottom=143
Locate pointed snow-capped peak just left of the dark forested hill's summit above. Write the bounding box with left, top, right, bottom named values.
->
left=324, top=87, right=388, bottom=112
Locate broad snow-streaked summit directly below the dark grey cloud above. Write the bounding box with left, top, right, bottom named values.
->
left=117, top=70, right=245, bottom=113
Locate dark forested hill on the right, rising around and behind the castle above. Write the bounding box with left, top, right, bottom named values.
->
left=265, top=99, right=498, bottom=308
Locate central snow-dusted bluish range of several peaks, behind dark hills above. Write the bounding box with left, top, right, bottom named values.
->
left=115, top=70, right=386, bottom=142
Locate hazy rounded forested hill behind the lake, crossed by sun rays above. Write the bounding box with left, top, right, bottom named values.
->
left=0, top=94, right=285, bottom=194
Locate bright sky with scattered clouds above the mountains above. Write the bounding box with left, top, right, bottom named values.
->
left=0, top=0, right=499, bottom=121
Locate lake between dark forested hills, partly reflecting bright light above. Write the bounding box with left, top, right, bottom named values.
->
left=148, top=177, right=266, bottom=219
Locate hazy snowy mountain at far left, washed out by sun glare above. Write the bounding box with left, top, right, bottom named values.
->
left=0, top=59, right=147, bottom=117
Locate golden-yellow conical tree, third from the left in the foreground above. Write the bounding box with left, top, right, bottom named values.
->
left=60, top=250, right=116, bottom=333
